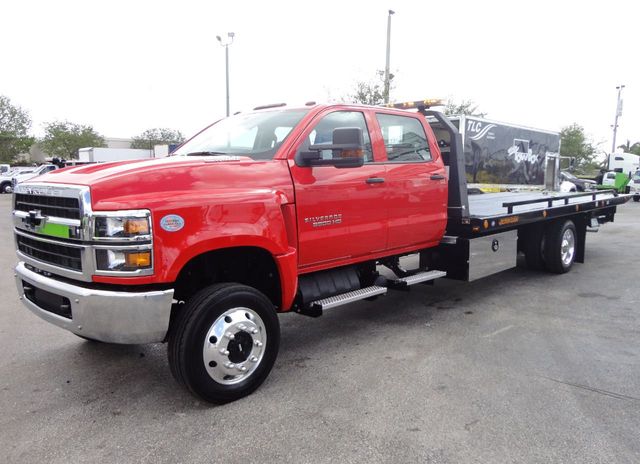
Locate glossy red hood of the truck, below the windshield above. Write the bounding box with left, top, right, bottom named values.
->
left=35, top=156, right=293, bottom=210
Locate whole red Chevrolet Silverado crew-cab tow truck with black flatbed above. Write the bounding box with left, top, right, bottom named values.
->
left=13, top=104, right=628, bottom=402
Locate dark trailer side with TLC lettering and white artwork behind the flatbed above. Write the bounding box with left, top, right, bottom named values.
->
left=459, top=116, right=560, bottom=186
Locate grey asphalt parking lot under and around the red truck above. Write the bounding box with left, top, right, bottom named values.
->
left=0, top=195, right=640, bottom=463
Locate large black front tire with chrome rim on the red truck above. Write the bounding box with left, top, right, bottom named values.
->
left=168, top=283, right=280, bottom=403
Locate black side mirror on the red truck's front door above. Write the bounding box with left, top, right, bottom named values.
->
left=295, top=127, right=364, bottom=168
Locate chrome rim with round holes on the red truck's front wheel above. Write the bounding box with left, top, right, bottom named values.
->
left=202, top=307, right=267, bottom=385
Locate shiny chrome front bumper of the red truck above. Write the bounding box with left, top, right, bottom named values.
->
left=15, top=262, right=173, bottom=344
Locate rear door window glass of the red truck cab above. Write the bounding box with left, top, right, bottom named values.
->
left=376, top=114, right=431, bottom=162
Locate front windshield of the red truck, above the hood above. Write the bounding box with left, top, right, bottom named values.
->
left=174, top=110, right=308, bottom=160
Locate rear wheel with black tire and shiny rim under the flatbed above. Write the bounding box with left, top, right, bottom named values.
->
left=544, top=220, right=578, bottom=274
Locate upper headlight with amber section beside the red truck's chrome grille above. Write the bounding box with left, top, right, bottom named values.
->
left=93, top=211, right=151, bottom=240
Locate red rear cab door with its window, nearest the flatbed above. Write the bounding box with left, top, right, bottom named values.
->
left=376, top=112, right=448, bottom=249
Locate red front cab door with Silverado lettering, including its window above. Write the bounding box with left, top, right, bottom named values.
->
left=289, top=110, right=387, bottom=269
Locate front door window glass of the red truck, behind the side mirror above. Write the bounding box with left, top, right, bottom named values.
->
left=300, top=111, right=373, bottom=163
